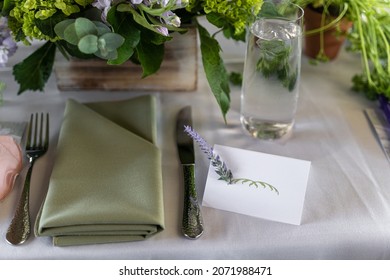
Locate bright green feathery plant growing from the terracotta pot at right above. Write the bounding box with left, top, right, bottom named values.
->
left=294, top=0, right=390, bottom=99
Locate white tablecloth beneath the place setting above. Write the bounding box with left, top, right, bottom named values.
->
left=0, top=35, right=390, bottom=259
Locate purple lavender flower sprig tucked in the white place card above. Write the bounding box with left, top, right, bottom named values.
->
left=184, top=125, right=233, bottom=184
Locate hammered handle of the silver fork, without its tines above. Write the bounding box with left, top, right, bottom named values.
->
left=6, top=162, right=33, bottom=245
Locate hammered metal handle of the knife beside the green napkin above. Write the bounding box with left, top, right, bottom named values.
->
left=182, top=164, right=203, bottom=239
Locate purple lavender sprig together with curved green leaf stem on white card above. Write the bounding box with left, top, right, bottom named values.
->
left=184, top=126, right=279, bottom=195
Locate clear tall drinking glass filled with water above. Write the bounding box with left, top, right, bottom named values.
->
left=241, top=0, right=303, bottom=139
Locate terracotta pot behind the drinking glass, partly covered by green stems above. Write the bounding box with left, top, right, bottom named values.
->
left=304, top=8, right=352, bottom=60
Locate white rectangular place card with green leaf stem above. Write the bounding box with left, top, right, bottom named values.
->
left=203, top=145, right=311, bottom=225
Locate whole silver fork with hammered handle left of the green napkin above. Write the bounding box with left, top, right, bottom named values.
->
left=6, top=113, right=49, bottom=245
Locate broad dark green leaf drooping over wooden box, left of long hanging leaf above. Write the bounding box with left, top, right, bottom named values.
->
left=136, top=40, right=164, bottom=78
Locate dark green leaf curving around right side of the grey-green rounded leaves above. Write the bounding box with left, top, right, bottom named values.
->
left=107, top=9, right=141, bottom=64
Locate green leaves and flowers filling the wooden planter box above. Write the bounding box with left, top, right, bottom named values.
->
left=0, top=0, right=263, bottom=121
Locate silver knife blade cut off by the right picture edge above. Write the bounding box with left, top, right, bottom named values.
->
left=365, top=109, right=390, bottom=161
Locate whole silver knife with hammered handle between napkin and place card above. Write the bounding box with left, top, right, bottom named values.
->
left=176, top=106, right=203, bottom=239
